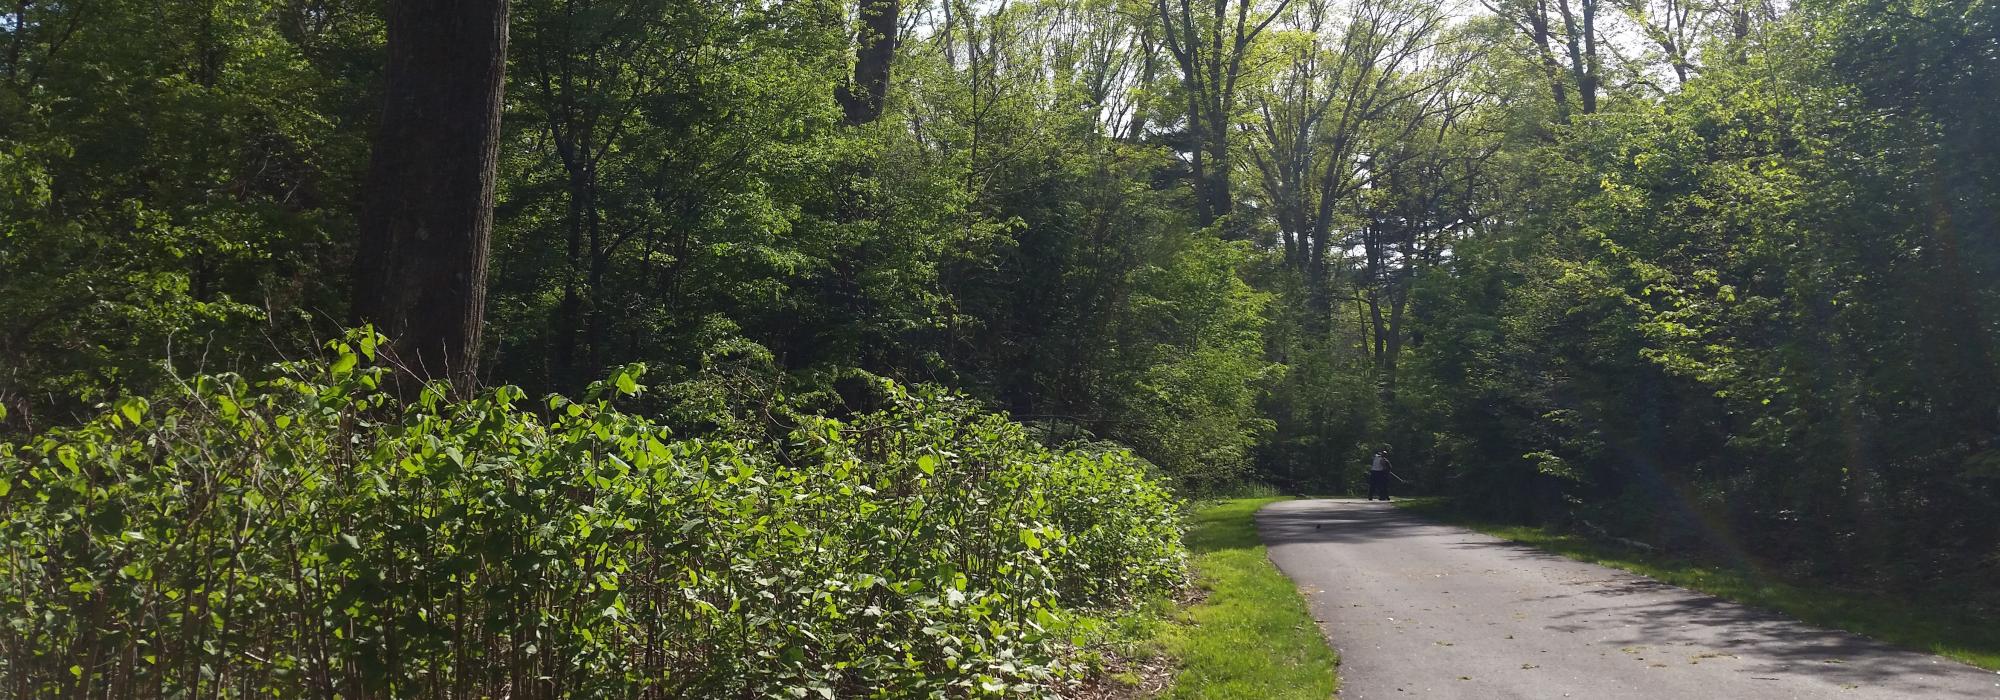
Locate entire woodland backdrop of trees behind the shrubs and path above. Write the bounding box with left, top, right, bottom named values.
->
left=0, top=0, right=2000, bottom=584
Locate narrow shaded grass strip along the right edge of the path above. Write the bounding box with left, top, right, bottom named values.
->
left=1396, top=498, right=2000, bottom=670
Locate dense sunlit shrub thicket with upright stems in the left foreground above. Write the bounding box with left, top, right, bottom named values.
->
left=0, top=336, right=1182, bottom=698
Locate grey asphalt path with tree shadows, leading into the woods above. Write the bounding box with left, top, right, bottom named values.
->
left=1258, top=500, right=2000, bottom=700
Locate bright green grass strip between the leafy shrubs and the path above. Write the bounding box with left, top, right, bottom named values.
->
left=1150, top=498, right=1336, bottom=700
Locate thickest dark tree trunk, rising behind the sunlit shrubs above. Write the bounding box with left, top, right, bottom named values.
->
left=352, top=0, right=508, bottom=388
